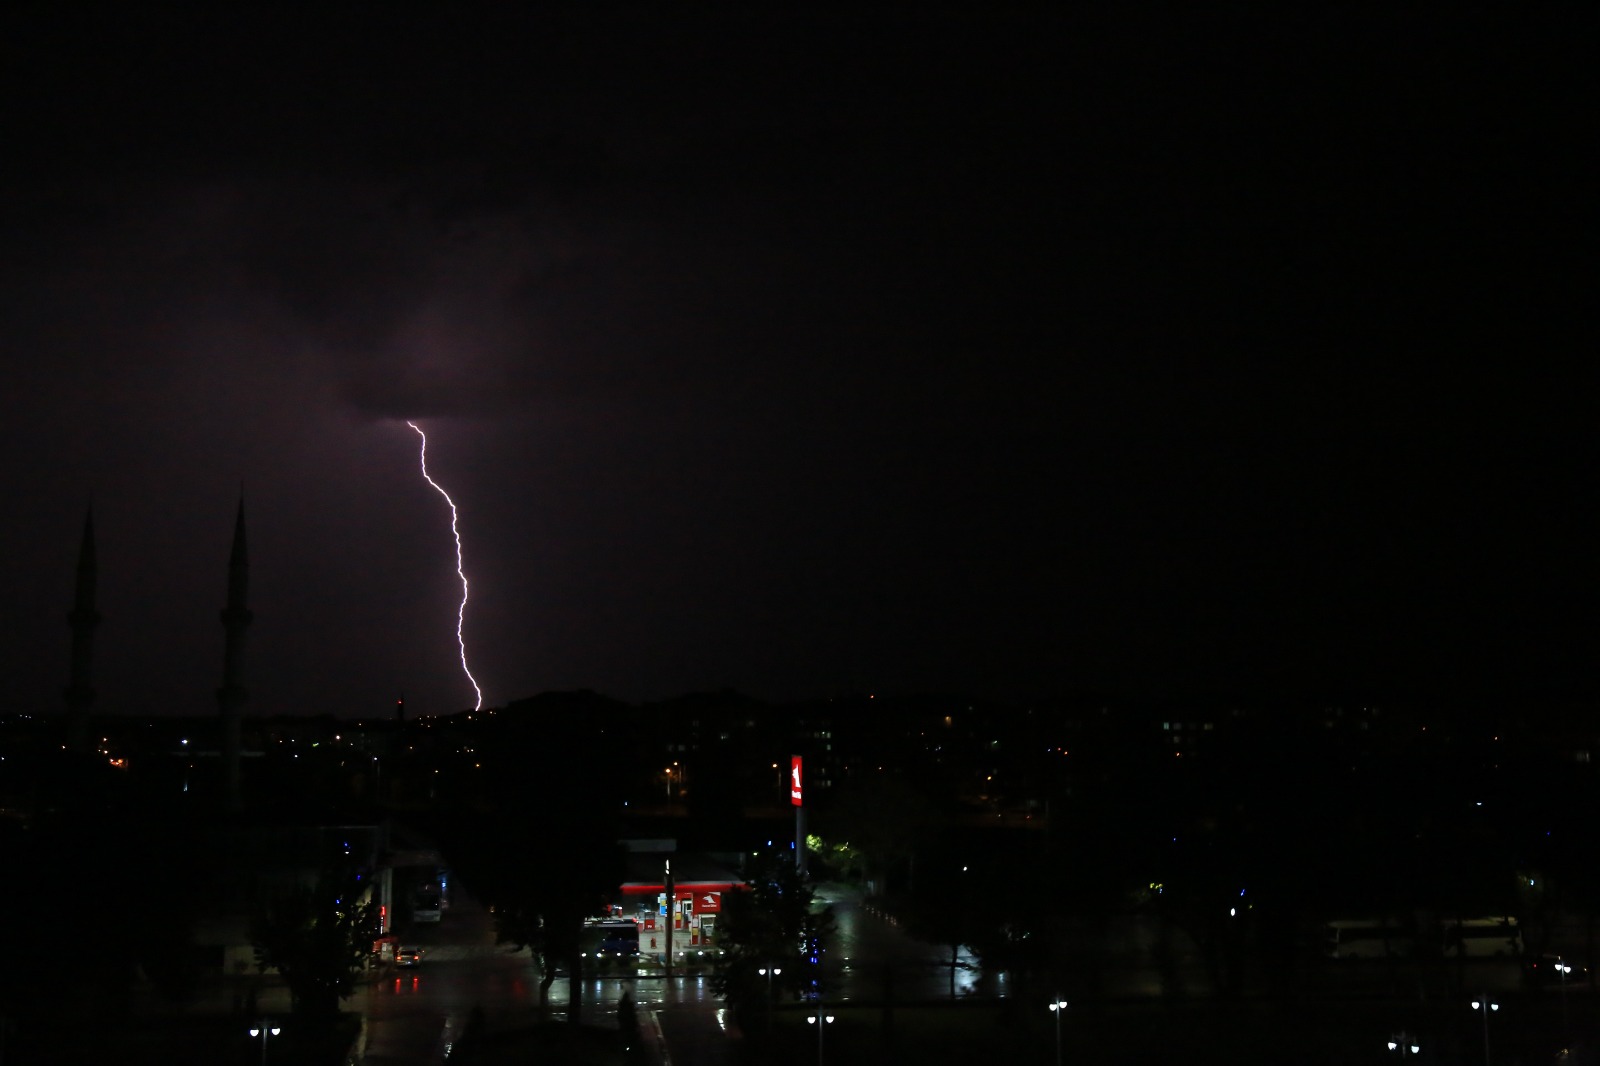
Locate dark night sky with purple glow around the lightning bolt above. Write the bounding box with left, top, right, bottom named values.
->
left=0, top=5, right=1600, bottom=715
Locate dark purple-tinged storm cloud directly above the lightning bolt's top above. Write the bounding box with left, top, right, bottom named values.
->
left=242, top=182, right=563, bottom=418
